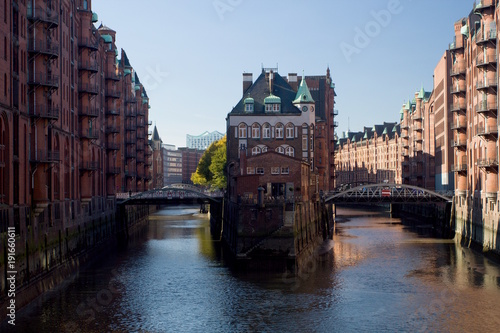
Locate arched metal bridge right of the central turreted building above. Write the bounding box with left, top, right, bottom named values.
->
left=325, top=183, right=453, bottom=204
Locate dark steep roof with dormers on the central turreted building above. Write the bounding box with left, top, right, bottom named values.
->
left=230, top=71, right=301, bottom=115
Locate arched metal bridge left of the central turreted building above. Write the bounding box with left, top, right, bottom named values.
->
left=117, top=184, right=224, bottom=205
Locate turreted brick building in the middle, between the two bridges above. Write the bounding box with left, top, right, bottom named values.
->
left=226, top=69, right=335, bottom=200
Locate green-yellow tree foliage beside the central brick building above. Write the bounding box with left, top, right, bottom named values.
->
left=191, top=136, right=227, bottom=189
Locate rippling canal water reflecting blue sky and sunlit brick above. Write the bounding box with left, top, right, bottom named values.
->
left=0, top=207, right=500, bottom=332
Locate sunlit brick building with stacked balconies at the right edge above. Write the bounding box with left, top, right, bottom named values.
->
left=449, top=0, right=500, bottom=252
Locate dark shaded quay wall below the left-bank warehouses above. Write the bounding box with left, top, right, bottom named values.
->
left=0, top=199, right=155, bottom=321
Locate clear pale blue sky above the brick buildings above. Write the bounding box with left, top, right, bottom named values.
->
left=92, top=0, right=473, bottom=147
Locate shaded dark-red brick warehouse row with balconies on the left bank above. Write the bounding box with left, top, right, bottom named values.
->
left=0, top=0, right=152, bottom=290
